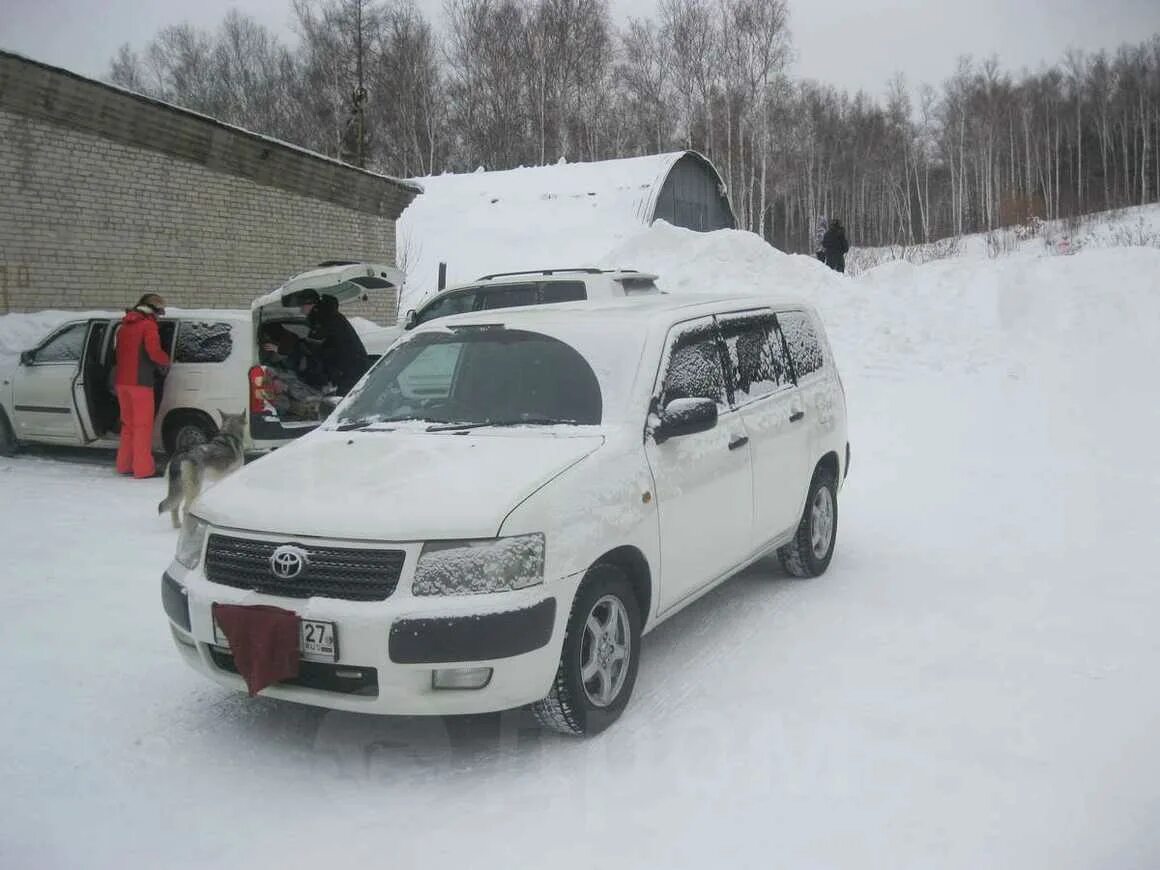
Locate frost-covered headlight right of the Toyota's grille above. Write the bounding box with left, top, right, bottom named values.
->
left=412, top=535, right=544, bottom=595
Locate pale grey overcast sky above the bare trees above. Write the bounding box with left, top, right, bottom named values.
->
left=0, top=0, right=1160, bottom=95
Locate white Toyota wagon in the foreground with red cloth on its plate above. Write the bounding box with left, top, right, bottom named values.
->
left=161, top=296, right=849, bottom=734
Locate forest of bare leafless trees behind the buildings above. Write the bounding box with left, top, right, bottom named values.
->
left=108, top=0, right=1160, bottom=251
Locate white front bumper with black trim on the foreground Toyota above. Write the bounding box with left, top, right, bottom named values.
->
left=161, top=566, right=580, bottom=716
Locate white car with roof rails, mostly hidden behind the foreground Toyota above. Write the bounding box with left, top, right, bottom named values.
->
left=367, top=268, right=661, bottom=355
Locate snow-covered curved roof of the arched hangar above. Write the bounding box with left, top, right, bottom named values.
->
left=397, top=151, right=689, bottom=309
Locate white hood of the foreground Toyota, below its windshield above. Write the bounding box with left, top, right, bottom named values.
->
left=194, top=429, right=604, bottom=542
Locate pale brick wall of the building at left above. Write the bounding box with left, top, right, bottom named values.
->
left=0, top=109, right=398, bottom=322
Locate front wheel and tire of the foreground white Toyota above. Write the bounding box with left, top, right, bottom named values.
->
left=531, top=564, right=640, bottom=735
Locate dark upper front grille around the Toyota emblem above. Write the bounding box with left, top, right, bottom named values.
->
left=205, top=535, right=406, bottom=601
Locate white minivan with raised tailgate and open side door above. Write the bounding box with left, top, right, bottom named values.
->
left=0, top=262, right=403, bottom=455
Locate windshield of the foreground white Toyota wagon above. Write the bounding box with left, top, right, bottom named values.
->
left=333, top=326, right=604, bottom=429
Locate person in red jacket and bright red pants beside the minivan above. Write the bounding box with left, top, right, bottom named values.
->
left=114, top=293, right=169, bottom=478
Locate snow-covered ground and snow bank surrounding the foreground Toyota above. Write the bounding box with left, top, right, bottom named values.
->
left=0, top=227, right=1160, bottom=870
